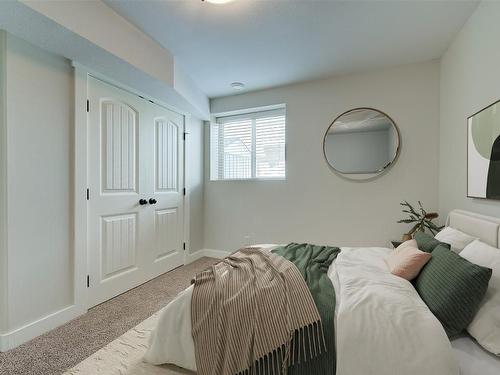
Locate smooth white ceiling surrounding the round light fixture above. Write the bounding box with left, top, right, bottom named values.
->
left=105, top=0, right=477, bottom=97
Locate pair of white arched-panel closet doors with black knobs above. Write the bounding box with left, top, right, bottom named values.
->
left=88, top=78, right=184, bottom=306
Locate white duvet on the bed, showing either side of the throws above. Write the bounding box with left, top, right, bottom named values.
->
left=144, top=246, right=459, bottom=375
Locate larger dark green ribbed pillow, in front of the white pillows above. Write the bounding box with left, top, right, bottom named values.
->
left=415, top=245, right=492, bottom=338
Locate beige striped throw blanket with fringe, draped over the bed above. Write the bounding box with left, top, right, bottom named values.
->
left=191, top=248, right=325, bottom=375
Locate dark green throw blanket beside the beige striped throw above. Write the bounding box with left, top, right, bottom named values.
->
left=272, top=243, right=340, bottom=375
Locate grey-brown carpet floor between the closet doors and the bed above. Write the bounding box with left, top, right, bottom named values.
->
left=0, top=258, right=216, bottom=375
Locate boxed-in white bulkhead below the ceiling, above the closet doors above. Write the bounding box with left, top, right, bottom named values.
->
left=0, top=1, right=210, bottom=119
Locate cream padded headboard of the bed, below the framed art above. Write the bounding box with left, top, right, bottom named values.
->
left=446, top=210, right=500, bottom=247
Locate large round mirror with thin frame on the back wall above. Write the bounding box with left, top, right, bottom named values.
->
left=323, top=108, right=400, bottom=180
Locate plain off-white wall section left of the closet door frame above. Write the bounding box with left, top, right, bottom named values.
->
left=4, top=35, right=73, bottom=331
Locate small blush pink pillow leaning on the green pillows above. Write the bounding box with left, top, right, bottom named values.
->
left=386, top=240, right=432, bottom=281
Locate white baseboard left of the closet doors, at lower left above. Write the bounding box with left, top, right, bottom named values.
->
left=0, top=305, right=87, bottom=352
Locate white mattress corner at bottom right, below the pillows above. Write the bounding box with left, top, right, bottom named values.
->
left=451, top=336, right=500, bottom=375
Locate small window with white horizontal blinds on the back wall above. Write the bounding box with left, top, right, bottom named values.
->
left=210, top=108, right=285, bottom=180
